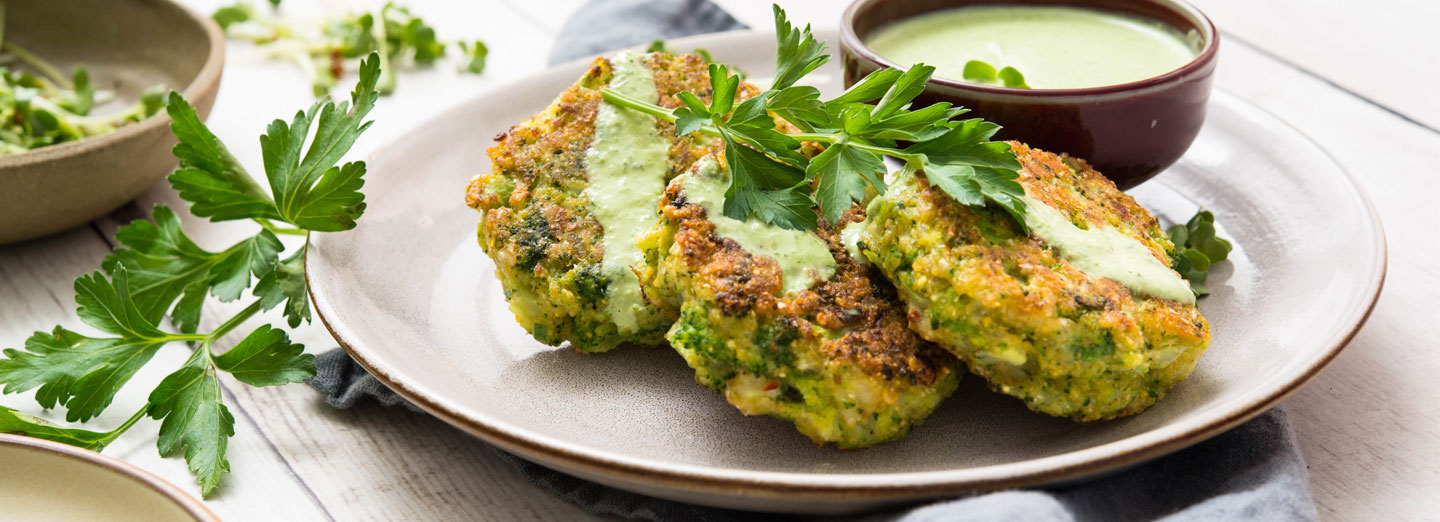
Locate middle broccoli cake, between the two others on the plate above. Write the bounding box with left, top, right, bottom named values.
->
left=641, top=159, right=962, bottom=448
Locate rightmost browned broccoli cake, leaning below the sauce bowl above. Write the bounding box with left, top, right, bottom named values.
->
left=847, top=143, right=1210, bottom=421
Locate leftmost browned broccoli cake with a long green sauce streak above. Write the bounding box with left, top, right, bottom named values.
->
left=465, top=52, right=757, bottom=352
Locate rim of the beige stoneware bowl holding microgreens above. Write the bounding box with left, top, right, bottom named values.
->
left=0, top=0, right=225, bottom=173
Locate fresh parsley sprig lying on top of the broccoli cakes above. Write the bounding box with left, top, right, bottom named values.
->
left=600, top=6, right=1025, bottom=229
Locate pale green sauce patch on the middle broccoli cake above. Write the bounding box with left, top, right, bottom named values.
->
left=675, top=159, right=835, bottom=294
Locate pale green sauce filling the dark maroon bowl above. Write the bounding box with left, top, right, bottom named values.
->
left=865, top=6, right=1200, bottom=89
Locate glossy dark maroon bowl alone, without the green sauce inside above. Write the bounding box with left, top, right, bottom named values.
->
left=840, top=0, right=1220, bottom=189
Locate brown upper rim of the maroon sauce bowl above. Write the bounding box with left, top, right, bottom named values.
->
left=840, top=0, right=1220, bottom=98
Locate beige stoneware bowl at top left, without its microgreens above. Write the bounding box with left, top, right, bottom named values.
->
left=0, top=0, right=225, bottom=245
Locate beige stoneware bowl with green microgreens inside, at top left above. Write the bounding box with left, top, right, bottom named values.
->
left=0, top=0, right=225, bottom=244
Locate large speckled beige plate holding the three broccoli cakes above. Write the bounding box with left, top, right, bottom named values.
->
left=307, top=33, right=1385, bottom=512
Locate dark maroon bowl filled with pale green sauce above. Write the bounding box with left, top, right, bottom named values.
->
left=840, top=0, right=1220, bottom=189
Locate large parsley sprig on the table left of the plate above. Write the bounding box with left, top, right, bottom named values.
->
left=0, top=55, right=382, bottom=495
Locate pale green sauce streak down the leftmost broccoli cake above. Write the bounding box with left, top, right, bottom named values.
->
left=585, top=50, right=670, bottom=332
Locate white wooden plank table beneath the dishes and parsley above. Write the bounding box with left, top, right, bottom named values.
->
left=0, top=0, right=1440, bottom=521
